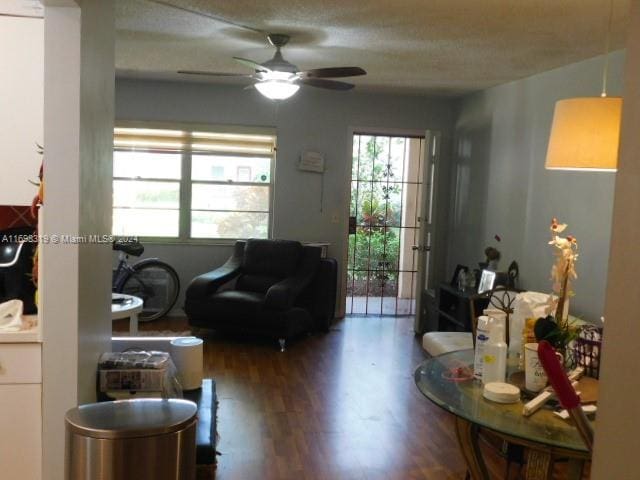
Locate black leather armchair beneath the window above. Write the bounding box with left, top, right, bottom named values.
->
left=185, top=239, right=337, bottom=349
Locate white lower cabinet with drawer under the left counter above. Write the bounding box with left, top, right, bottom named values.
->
left=0, top=344, right=42, bottom=480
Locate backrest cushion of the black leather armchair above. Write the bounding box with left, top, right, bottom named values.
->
left=236, top=239, right=303, bottom=293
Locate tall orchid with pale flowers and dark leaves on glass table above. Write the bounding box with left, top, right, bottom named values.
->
left=534, top=218, right=578, bottom=350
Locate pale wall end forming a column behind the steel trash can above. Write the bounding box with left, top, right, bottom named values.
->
left=40, top=0, right=115, bottom=480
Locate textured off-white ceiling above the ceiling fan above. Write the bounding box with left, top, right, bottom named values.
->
left=116, top=0, right=630, bottom=95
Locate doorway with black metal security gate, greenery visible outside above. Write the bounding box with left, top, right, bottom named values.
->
left=346, top=132, right=425, bottom=316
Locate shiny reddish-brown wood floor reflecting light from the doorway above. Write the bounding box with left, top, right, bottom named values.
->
left=114, top=316, right=584, bottom=480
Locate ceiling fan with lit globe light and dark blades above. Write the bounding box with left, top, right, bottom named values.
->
left=178, top=33, right=367, bottom=100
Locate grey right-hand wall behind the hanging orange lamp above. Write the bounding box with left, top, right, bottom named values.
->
left=448, top=52, right=624, bottom=321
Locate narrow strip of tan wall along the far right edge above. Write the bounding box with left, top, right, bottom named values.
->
left=591, top=2, right=640, bottom=480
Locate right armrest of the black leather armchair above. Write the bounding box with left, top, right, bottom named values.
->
left=265, top=247, right=321, bottom=310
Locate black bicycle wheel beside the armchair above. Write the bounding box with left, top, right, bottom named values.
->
left=120, top=259, right=180, bottom=322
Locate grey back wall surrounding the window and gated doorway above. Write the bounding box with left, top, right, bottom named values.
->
left=116, top=79, right=452, bottom=316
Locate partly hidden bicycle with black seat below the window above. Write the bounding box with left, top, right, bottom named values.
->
left=111, top=240, right=180, bottom=322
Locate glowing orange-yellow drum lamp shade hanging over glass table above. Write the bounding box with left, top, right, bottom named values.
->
left=545, top=97, right=622, bottom=172
